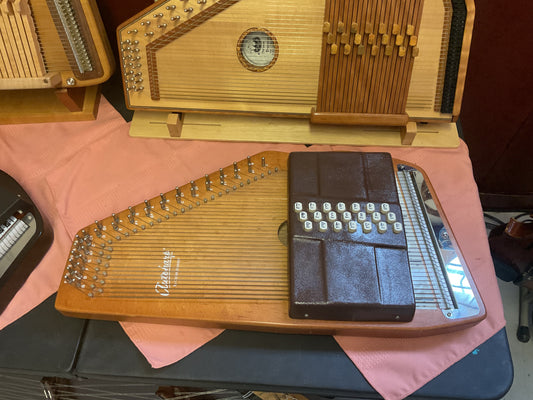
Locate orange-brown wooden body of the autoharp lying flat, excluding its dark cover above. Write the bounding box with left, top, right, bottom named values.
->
left=55, top=152, right=485, bottom=337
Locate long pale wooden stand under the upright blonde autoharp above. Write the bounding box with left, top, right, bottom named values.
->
left=130, top=111, right=460, bottom=148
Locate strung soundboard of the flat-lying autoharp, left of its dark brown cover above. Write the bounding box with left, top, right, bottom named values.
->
left=70, top=156, right=288, bottom=300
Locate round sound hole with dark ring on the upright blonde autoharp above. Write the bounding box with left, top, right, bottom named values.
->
left=237, top=28, right=279, bottom=72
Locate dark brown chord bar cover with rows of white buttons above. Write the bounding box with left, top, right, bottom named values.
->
left=289, top=152, right=415, bottom=322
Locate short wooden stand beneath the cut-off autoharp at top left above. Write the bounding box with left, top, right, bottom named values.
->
left=0, top=86, right=100, bottom=124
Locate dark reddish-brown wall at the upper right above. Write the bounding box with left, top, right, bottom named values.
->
left=460, top=0, right=533, bottom=210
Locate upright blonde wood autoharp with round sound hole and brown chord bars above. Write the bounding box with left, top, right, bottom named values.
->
left=118, top=0, right=474, bottom=130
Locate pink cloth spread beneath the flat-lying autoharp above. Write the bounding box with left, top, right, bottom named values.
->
left=0, top=99, right=505, bottom=400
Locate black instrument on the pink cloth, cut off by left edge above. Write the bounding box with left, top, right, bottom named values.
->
left=0, top=171, right=53, bottom=313
